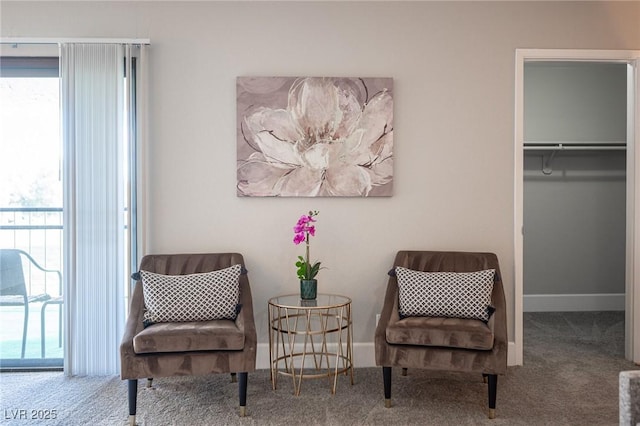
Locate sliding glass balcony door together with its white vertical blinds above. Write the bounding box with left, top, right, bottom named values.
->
left=0, top=42, right=146, bottom=375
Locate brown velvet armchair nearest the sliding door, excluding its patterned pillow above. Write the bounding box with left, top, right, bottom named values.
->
left=120, top=253, right=257, bottom=425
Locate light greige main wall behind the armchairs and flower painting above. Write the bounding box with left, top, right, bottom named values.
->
left=0, top=0, right=640, bottom=352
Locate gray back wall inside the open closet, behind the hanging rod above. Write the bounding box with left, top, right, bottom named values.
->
left=524, top=62, right=627, bottom=311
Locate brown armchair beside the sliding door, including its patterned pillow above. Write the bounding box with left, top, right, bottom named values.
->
left=120, top=253, right=257, bottom=425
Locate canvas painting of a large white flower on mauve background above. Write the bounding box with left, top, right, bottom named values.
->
left=237, top=77, right=393, bottom=197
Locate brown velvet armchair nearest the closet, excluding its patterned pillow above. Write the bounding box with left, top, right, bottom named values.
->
left=375, top=251, right=508, bottom=418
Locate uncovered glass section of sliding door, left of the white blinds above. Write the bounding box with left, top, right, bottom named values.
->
left=0, top=46, right=64, bottom=368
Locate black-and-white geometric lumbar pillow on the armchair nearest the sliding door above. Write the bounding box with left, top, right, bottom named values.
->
left=140, top=264, right=242, bottom=326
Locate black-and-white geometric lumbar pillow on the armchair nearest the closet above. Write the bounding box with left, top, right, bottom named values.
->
left=395, top=266, right=496, bottom=322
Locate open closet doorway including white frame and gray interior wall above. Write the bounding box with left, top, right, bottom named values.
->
left=510, top=50, right=640, bottom=365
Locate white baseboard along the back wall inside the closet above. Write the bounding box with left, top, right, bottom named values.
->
left=523, top=293, right=625, bottom=312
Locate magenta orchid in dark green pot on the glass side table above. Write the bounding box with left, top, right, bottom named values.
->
left=293, top=211, right=320, bottom=299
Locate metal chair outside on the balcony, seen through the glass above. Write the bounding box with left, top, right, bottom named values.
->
left=0, top=249, right=62, bottom=358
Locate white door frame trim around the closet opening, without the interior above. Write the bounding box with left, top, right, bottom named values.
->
left=509, top=49, right=640, bottom=365
